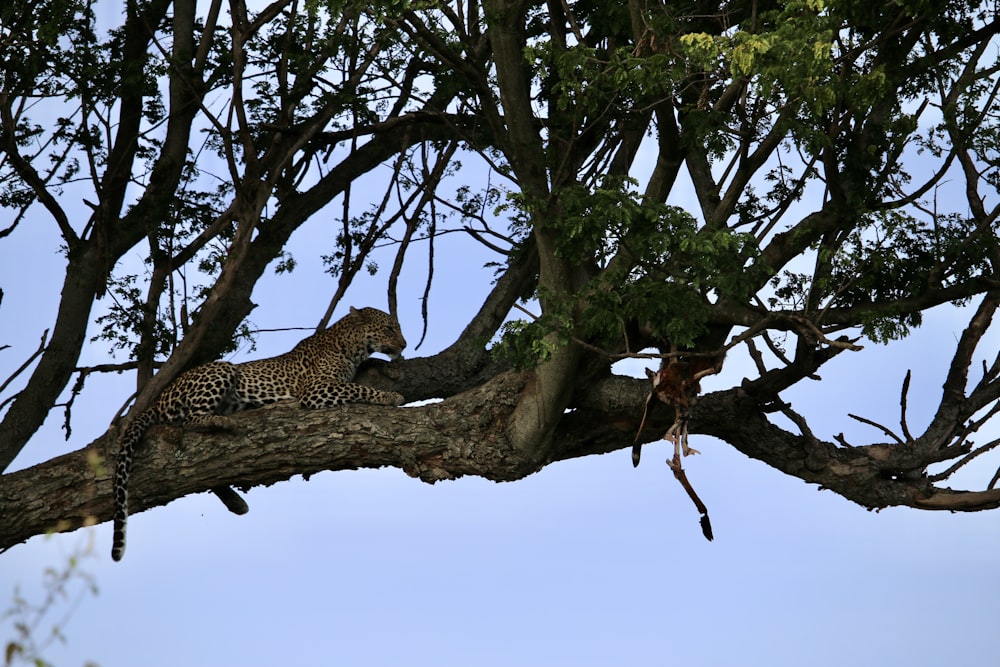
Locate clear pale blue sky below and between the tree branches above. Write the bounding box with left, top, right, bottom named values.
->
left=0, top=5, right=1000, bottom=667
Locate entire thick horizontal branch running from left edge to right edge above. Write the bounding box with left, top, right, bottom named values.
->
left=0, top=364, right=1000, bottom=549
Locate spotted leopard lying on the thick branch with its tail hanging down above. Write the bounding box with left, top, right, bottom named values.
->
left=111, top=306, right=406, bottom=561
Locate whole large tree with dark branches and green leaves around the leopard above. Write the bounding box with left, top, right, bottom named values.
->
left=0, top=0, right=1000, bottom=547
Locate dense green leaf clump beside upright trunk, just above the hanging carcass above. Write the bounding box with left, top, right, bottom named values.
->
left=501, top=177, right=757, bottom=364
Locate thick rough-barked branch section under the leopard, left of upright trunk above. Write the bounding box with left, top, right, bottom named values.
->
left=0, top=376, right=532, bottom=549
